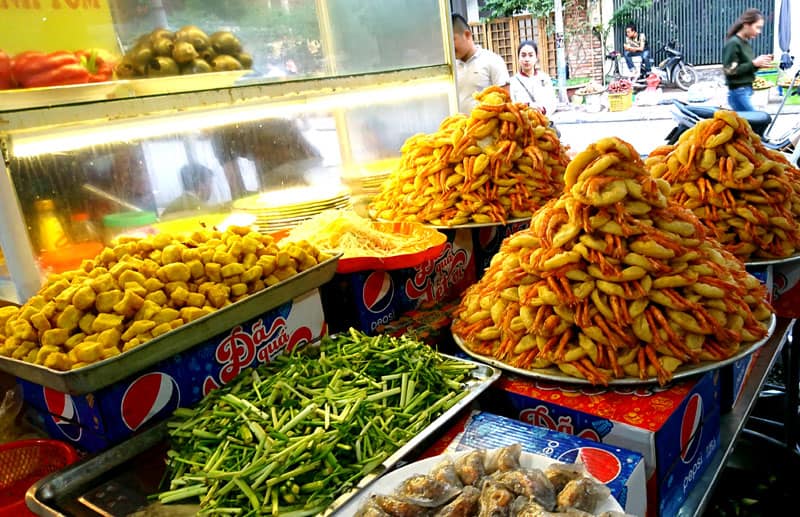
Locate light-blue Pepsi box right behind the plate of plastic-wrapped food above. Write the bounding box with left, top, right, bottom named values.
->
left=446, top=411, right=647, bottom=515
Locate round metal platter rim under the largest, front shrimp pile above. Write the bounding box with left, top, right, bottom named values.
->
left=453, top=314, right=777, bottom=386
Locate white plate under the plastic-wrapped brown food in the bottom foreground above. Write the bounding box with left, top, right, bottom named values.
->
left=335, top=451, right=625, bottom=517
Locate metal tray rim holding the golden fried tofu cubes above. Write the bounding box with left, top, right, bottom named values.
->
left=0, top=254, right=341, bottom=395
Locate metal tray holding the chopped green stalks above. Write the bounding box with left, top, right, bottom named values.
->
left=25, top=354, right=501, bottom=517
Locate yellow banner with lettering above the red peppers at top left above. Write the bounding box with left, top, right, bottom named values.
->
left=0, top=0, right=120, bottom=55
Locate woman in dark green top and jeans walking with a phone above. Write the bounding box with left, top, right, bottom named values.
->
left=722, top=9, right=772, bottom=111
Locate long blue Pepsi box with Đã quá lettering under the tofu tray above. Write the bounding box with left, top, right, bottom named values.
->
left=17, top=289, right=327, bottom=452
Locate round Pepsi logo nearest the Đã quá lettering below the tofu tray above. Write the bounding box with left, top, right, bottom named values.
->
left=120, top=372, right=181, bottom=431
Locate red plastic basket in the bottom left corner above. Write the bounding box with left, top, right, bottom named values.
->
left=0, top=440, right=78, bottom=517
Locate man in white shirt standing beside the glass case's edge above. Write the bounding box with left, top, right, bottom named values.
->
left=453, top=14, right=509, bottom=114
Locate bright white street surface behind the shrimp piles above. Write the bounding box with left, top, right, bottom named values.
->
left=550, top=82, right=800, bottom=155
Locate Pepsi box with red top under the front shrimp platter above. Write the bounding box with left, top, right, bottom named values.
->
left=491, top=370, right=720, bottom=516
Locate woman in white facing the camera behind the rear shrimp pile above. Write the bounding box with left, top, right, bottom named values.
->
left=511, top=40, right=556, bottom=116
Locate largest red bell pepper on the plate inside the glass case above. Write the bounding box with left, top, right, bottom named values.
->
left=11, top=51, right=90, bottom=88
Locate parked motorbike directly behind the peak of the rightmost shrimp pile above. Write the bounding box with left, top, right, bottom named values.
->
left=665, top=69, right=800, bottom=166
